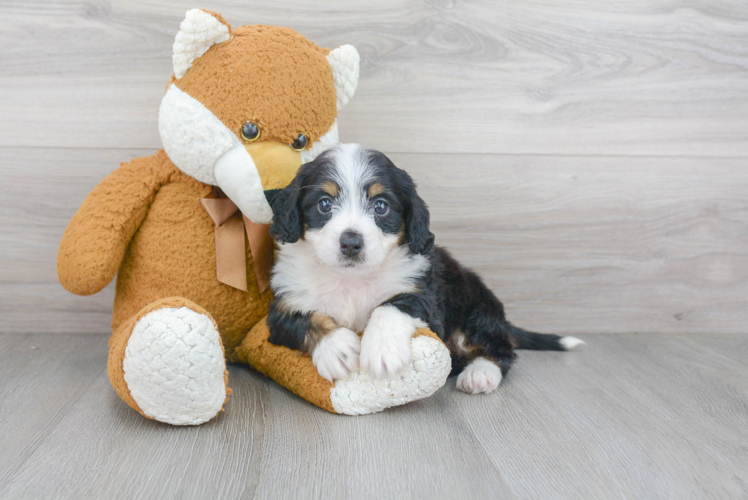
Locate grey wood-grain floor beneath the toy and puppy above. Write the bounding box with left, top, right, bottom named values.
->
left=0, top=334, right=748, bottom=500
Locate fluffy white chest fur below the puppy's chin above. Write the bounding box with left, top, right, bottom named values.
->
left=271, top=238, right=429, bottom=332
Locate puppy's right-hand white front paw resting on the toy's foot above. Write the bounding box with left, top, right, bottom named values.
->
left=361, top=306, right=416, bottom=378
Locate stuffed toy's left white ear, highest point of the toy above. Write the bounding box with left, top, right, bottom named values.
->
left=172, top=9, right=231, bottom=79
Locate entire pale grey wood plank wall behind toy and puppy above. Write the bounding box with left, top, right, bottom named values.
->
left=0, top=0, right=748, bottom=333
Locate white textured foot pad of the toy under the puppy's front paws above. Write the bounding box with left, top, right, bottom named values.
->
left=330, top=335, right=452, bottom=415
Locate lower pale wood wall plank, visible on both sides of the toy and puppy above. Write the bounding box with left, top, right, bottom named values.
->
left=0, top=148, right=748, bottom=333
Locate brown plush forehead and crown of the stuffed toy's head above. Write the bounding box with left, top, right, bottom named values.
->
left=174, top=25, right=334, bottom=144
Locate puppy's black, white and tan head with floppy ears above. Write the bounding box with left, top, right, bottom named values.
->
left=268, top=144, right=434, bottom=273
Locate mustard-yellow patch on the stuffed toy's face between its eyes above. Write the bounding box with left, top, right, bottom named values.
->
left=244, top=141, right=302, bottom=191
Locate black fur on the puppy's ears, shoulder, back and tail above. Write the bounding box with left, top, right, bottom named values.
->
left=267, top=146, right=565, bottom=375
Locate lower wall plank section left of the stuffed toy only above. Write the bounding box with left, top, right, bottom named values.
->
left=0, top=148, right=152, bottom=333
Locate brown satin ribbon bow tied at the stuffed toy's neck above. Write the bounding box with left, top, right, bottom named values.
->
left=200, top=192, right=273, bottom=293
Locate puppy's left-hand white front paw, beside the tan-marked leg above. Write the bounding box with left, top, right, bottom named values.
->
left=312, top=327, right=361, bottom=382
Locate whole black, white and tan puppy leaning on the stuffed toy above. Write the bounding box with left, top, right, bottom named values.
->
left=268, top=144, right=582, bottom=394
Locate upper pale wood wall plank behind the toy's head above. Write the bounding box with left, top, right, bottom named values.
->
left=0, top=0, right=748, bottom=156
